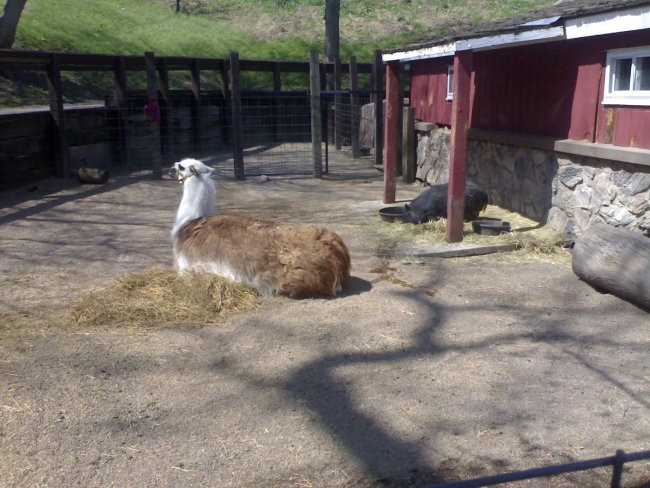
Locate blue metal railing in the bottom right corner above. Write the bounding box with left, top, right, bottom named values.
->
left=428, top=450, right=650, bottom=488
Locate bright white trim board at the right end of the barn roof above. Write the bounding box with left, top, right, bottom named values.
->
left=564, top=5, right=650, bottom=39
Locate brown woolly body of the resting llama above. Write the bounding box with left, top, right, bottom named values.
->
left=176, top=214, right=350, bottom=298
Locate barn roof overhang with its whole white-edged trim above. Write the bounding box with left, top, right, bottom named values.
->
left=382, top=0, right=650, bottom=62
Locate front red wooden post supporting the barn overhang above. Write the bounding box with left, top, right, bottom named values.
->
left=445, top=51, right=472, bottom=242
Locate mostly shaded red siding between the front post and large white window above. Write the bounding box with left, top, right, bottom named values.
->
left=472, top=42, right=600, bottom=140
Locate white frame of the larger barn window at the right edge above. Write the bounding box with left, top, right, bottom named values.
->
left=603, top=46, right=650, bottom=106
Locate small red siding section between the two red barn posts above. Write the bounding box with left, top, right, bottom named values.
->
left=404, top=56, right=454, bottom=125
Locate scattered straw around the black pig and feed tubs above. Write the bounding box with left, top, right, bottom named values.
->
left=380, top=205, right=570, bottom=261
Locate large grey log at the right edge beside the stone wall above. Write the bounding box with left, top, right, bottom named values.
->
left=572, top=224, right=650, bottom=310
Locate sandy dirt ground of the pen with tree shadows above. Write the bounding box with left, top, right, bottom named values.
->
left=0, top=156, right=650, bottom=488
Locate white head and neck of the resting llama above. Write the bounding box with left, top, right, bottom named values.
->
left=169, top=159, right=217, bottom=234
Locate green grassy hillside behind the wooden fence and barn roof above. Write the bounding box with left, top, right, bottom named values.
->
left=14, top=0, right=553, bottom=61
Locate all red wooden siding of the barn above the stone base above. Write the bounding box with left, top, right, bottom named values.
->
left=411, top=30, right=650, bottom=148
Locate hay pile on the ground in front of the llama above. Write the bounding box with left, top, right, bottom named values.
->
left=68, top=268, right=259, bottom=326
